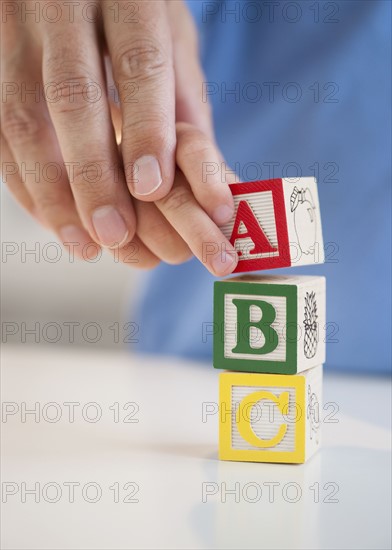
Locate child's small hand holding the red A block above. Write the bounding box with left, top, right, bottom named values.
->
left=115, top=122, right=238, bottom=276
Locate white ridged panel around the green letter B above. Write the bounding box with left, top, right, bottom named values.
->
left=224, top=294, right=287, bottom=362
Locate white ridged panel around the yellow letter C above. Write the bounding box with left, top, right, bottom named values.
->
left=231, top=386, right=296, bottom=453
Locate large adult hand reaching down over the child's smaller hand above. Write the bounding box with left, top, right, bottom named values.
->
left=2, top=0, right=236, bottom=274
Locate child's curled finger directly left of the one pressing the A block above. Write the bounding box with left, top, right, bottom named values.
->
left=135, top=201, right=192, bottom=264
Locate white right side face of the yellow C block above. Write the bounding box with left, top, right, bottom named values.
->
left=303, top=365, right=323, bottom=459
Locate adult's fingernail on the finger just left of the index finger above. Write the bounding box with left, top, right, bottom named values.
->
left=92, top=206, right=128, bottom=248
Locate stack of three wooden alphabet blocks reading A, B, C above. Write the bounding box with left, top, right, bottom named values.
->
left=213, top=178, right=326, bottom=463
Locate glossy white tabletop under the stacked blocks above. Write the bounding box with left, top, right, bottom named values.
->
left=1, top=345, right=391, bottom=550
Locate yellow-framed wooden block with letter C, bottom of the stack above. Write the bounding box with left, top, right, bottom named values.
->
left=219, top=365, right=322, bottom=463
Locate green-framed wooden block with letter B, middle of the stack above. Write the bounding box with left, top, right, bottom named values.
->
left=214, top=275, right=326, bottom=374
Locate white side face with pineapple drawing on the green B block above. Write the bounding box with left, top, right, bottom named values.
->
left=297, top=277, right=326, bottom=372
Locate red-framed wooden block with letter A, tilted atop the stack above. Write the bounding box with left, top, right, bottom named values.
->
left=221, top=177, right=324, bottom=272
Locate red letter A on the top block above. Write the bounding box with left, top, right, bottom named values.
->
left=230, top=200, right=278, bottom=256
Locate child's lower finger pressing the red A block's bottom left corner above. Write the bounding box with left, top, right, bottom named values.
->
left=156, top=170, right=238, bottom=277
